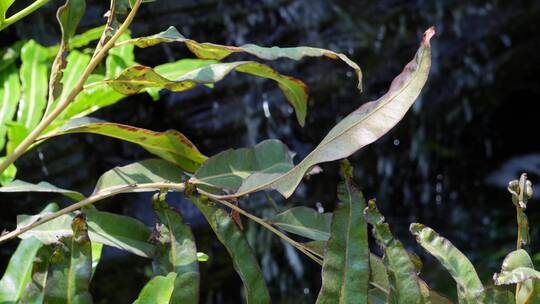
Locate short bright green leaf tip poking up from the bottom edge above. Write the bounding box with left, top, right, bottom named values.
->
left=133, top=272, right=176, bottom=304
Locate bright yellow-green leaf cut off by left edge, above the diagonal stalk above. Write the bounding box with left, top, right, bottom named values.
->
left=0, top=64, right=21, bottom=151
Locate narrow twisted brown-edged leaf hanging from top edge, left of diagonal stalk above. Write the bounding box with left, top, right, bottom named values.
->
left=48, top=0, right=86, bottom=110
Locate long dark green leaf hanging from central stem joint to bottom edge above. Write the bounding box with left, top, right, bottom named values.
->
left=190, top=196, right=270, bottom=303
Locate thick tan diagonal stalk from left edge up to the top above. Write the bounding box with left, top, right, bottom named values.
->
left=0, top=0, right=142, bottom=173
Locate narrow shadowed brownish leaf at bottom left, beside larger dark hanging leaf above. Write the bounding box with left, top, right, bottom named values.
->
left=21, top=246, right=53, bottom=304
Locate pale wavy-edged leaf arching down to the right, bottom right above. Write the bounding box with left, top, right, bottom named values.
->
left=410, top=223, right=484, bottom=303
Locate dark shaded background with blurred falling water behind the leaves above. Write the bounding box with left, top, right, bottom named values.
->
left=0, top=0, right=540, bottom=303
